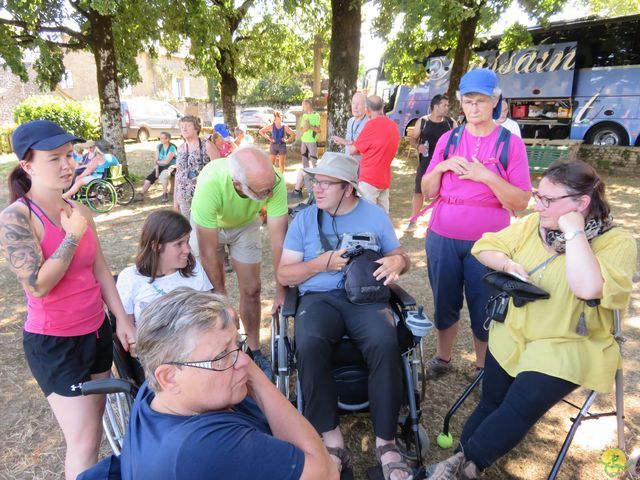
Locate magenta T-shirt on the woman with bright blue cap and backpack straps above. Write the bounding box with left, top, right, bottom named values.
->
left=425, top=127, right=531, bottom=241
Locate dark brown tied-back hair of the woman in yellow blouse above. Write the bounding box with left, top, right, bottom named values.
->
left=543, top=160, right=611, bottom=220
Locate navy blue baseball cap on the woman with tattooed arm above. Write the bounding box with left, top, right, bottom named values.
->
left=11, top=120, right=84, bottom=160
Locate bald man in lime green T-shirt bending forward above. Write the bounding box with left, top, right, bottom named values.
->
left=191, top=146, right=288, bottom=378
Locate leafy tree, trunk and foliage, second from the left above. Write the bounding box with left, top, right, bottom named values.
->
left=164, top=0, right=311, bottom=127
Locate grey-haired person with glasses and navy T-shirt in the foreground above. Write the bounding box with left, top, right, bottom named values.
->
left=117, top=287, right=338, bottom=480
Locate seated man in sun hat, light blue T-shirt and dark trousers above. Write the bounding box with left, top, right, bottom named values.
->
left=278, top=152, right=411, bottom=480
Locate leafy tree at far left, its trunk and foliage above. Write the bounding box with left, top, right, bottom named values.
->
left=0, top=0, right=166, bottom=169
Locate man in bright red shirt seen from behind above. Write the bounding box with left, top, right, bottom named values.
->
left=350, top=95, right=400, bottom=213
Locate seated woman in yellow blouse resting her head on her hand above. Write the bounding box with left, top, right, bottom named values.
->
left=429, top=162, right=637, bottom=480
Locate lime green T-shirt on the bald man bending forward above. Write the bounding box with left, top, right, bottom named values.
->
left=191, top=158, right=288, bottom=228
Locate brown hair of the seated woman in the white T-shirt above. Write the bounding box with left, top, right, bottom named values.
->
left=136, top=210, right=196, bottom=283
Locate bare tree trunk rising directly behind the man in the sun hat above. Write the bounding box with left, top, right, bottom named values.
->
left=327, top=0, right=362, bottom=151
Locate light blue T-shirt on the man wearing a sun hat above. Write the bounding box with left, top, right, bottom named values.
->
left=284, top=199, right=400, bottom=294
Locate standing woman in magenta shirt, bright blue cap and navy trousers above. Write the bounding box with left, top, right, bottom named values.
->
left=422, top=69, right=531, bottom=378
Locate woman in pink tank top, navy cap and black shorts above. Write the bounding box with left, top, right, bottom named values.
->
left=0, top=120, right=135, bottom=480
